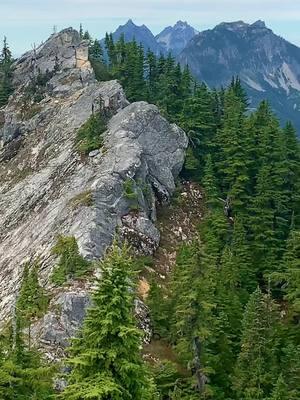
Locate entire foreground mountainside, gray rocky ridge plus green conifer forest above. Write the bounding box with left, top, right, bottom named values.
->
left=0, top=30, right=300, bottom=400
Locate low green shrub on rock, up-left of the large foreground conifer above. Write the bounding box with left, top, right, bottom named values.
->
left=51, top=236, right=92, bottom=285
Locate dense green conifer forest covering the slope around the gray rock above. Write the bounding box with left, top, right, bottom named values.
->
left=0, top=30, right=300, bottom=400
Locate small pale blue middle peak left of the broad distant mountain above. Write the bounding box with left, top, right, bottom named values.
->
left=155, top=21, right=198, bottom=56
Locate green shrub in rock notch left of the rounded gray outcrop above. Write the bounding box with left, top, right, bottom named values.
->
left=76, top=113, right=107, bottom=154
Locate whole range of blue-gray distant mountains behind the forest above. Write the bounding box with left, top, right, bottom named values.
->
left=101, top=20, right=300, bottom=132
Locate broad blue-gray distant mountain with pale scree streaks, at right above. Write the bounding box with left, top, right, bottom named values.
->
left=179, top=21, right=300, bottom=130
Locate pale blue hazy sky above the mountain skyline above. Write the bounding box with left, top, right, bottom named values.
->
left=0, top=0, right=300, bottom=56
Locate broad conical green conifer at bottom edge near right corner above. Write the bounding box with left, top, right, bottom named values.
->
left=233, top=288, right=279, bottom=400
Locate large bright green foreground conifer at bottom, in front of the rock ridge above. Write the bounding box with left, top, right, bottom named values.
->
left=59, top=245, right=155, bottom=400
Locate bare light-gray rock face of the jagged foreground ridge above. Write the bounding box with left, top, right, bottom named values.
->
left=0, top=29, right=187, bottom=345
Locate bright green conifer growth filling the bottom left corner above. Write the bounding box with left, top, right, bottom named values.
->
left=0, top=286, right=55, bottom=400
